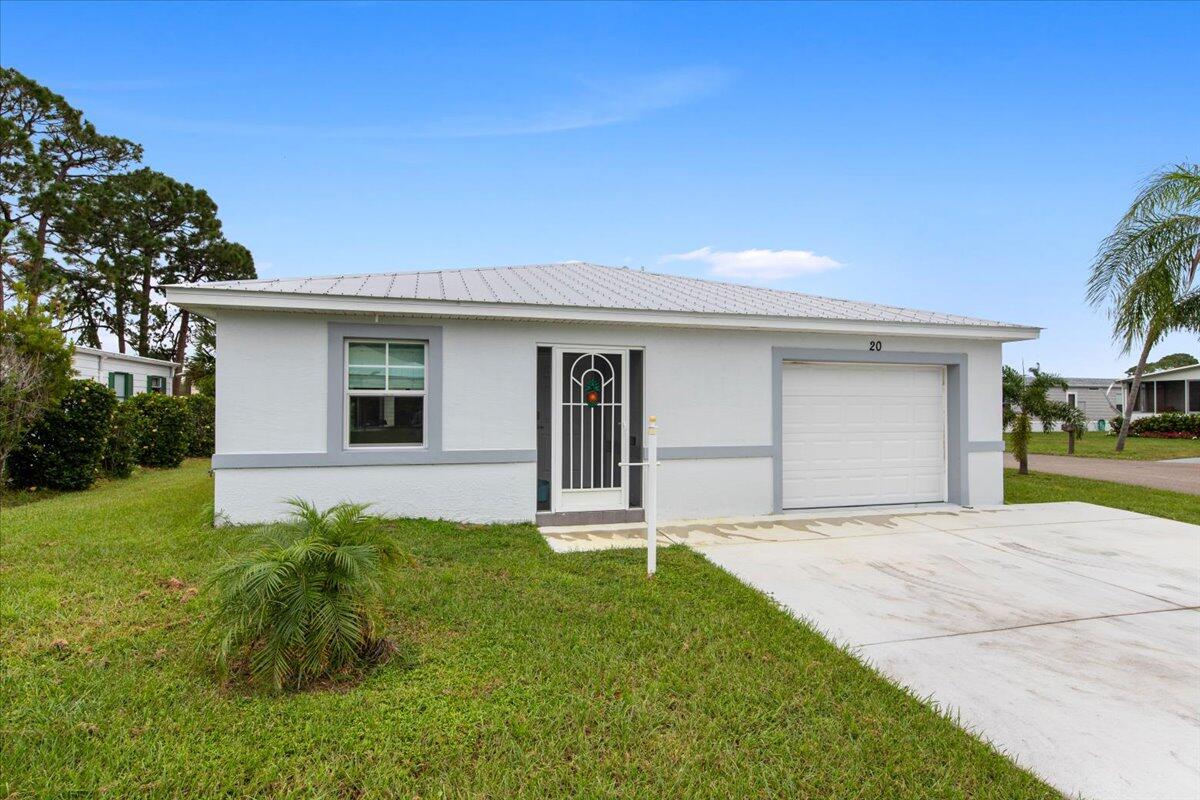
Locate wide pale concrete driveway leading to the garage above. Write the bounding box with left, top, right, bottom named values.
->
left=666, top=503, right=1200, bottom=800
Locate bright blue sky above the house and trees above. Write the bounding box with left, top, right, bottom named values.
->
left=0, top=2, right=1200, bottom=375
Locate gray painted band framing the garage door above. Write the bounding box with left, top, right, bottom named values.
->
left=770, top=347, right=971, bottom=513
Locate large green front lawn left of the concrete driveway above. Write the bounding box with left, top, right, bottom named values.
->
left=0, top=462, right=1058, bottom=799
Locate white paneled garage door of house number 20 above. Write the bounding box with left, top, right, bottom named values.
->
left=782, top=363, right=946, bottom=509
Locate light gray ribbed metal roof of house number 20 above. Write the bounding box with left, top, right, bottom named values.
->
left=182, top=261, right=1027, bottom=327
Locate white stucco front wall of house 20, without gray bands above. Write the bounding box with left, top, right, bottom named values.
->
left=216, top=312, right=1003, bottom=521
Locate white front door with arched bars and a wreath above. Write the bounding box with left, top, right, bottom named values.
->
left=552, top=347, right=629, bottom=511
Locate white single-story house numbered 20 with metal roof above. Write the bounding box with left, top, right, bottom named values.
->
left=166, top=263, right=1039, bottom=523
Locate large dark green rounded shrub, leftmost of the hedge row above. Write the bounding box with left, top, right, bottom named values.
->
left=8, top=379, right=116, bottom=492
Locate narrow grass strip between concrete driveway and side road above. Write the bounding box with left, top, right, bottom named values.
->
left=1004, top=469, right=1200, bottom=525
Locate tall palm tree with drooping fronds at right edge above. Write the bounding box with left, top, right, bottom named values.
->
left=1087, top=164, right=1200, bottom=452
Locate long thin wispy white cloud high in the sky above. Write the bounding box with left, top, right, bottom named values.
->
left=114, top=67, right=730, bottom=139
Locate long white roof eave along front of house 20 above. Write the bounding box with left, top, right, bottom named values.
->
left=163, top=285, right=1042, bottom=342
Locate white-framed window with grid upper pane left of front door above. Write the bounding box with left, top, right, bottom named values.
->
left=343, top=339, right=427, bottom=447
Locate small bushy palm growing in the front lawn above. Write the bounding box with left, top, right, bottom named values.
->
left=206, top=499, right=400, bottom=692
